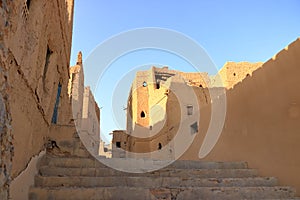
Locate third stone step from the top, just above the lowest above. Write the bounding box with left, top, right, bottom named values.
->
left=35, top=176, right=277, bottom=188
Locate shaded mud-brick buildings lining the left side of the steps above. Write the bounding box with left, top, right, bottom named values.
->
left=0, top=0, right=100, bottom=199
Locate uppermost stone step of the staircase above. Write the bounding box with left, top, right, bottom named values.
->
left=40, top=155, right=248, bottom=169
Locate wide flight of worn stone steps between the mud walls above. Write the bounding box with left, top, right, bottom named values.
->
left=29, top=136, right=296, bottom=200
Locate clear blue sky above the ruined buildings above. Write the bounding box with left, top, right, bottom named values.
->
left=71, top=0, right=300, bottom=142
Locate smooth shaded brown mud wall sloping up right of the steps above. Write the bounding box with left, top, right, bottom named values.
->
left=182, top=39, right=300, bottom=195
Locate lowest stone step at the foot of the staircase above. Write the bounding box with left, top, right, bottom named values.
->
left=29, top=187, right=295, bottom=200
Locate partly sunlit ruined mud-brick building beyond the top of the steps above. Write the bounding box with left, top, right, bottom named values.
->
left=113, top=62, right=263, bottom=159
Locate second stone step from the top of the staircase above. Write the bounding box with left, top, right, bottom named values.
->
left=39, top=166, right=258, bottom=178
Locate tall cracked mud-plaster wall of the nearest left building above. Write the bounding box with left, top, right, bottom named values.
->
left=1, top=0, right=73, bottom=189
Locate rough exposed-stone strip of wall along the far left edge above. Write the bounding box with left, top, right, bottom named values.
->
left=0, top=1, right=14, bottom=199
